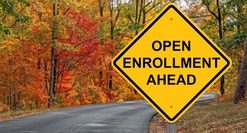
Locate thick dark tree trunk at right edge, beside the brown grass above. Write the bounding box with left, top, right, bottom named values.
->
left=233, top=38, right=247, bottom=104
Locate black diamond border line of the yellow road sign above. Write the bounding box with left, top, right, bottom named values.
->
left=113, top=5, right=230, bottom=121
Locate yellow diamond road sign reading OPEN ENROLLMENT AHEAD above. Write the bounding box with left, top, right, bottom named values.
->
left=113, top=4, right=231, bottom=123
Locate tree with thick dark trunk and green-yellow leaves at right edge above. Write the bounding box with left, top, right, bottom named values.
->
left=227, top=0, right=247, bottom=104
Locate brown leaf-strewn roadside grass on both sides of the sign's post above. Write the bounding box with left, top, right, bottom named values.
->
left=149, top=101, right=247, bottom=133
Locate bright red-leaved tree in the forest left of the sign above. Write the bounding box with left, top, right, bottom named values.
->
left=55, top=11, right=101, bottom=105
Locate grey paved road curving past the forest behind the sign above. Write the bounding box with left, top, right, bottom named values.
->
left=0, top=94, right=214, bottom=133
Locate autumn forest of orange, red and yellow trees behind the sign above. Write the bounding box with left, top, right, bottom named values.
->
left=0, top=0, right=247, bottom=113
